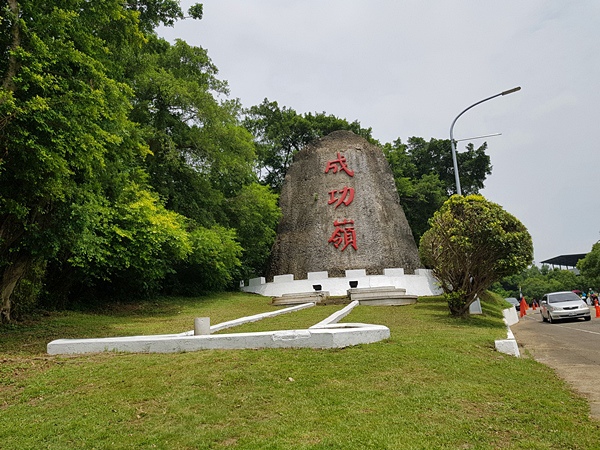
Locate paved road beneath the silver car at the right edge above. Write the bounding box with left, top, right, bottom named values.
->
left=510, top=308, right=600, bottom=419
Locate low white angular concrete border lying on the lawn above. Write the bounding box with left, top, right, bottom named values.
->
left=47, top=302, right=390, bottom=355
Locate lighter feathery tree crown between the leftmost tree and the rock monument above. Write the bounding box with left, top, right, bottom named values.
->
left=129, top=37, right=255, bottom=226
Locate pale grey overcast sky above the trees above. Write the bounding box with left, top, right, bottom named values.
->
left=160, top=0, right=600, bottom=263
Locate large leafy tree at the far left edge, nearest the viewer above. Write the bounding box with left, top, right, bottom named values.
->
left=0, top=0, right=150, bottom=321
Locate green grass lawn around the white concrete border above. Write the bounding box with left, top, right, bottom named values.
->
left=0, top=293, right=600, bottom=449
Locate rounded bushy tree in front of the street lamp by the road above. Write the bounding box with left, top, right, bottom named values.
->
left=419, top=195, right=533, bottom=317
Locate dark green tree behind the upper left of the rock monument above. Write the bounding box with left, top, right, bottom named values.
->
left=243, top=99, right=376, bottom=192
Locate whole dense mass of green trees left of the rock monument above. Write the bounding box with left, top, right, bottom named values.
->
left=0, top=0, right=278, bottom=321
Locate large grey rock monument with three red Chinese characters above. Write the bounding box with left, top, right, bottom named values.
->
left=267, top=131, right=419, bottom=280
